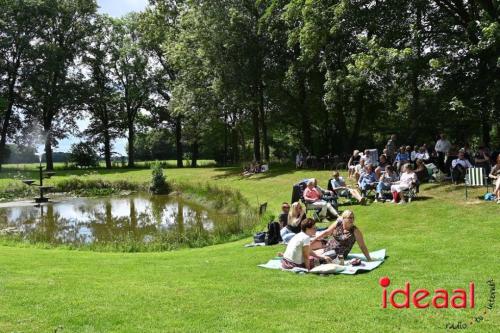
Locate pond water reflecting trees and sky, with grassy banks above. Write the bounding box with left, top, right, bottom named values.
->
left=0, top=194, right=249, bottom=249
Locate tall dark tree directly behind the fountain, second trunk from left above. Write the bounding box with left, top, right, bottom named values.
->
left=23, top=0, right=97, bottom=170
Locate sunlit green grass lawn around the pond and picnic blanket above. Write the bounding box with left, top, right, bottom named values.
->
left=0, top=167, right=500, bottom=332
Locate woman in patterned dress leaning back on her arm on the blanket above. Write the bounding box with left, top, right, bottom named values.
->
left=311, top=210, right=372, bottom=261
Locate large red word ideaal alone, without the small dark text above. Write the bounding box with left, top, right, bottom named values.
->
left=379, top=277, right=475, bottom=309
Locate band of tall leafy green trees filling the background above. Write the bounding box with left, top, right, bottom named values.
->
left=0, top=0, right=500, bottom=169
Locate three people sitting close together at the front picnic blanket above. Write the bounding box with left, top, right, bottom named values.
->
left=281, top=209, right=371, bottom=270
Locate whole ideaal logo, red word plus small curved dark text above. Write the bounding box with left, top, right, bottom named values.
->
left=379, top=277, right=496, bottom=330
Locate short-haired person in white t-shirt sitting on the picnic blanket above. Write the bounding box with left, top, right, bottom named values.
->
left=281, top=218, right=332, bottom=270
